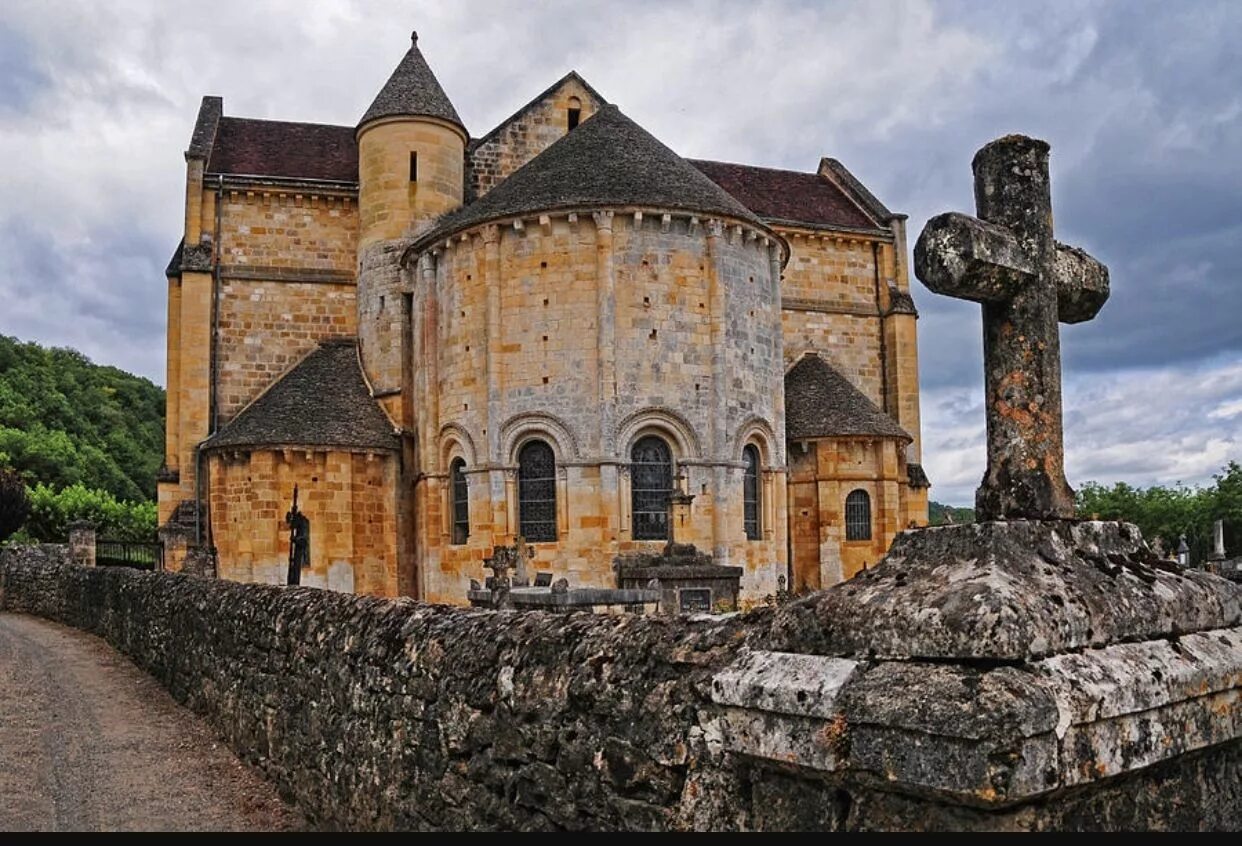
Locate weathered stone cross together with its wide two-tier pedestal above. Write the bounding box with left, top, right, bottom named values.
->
left=712, top=135, right=1242, bottom=829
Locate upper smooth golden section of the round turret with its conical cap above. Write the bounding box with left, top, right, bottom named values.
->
left=356, top=32, right=467, bottom=247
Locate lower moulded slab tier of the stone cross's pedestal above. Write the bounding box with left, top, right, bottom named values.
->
left=712, top=627, right=1242, bottom=807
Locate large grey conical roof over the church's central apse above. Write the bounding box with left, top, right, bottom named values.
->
left=415, top=104, right=763, bottom=248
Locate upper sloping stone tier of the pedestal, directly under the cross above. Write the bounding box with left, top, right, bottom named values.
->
left=773, top=521, right=1242, bottom=662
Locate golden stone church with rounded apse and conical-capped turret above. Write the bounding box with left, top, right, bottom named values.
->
left=159, top=31, right=929, bottom=603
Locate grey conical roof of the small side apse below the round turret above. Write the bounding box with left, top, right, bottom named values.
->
left=202, top=338, right=401, bottom=451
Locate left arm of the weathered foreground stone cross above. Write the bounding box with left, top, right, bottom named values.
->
left=914, top=211, right=1036, bottom=303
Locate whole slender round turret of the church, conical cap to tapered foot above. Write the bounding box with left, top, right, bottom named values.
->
left=356, top=32, right=468, bottom=426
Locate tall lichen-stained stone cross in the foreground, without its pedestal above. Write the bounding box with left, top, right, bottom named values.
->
left=914, top=135, right=1108, bottom=521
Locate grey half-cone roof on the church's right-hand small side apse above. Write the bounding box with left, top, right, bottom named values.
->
left=785, top=353, right=913, bottom=441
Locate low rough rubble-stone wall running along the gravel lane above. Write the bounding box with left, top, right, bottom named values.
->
left=0, top=549, right=1242, bottom=830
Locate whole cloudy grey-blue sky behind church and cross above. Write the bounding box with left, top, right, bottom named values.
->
left=0, top=0, right=1242, bottom=504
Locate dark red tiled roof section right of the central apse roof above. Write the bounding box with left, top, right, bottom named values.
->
left=689, top=159, right=879, bottom=229
